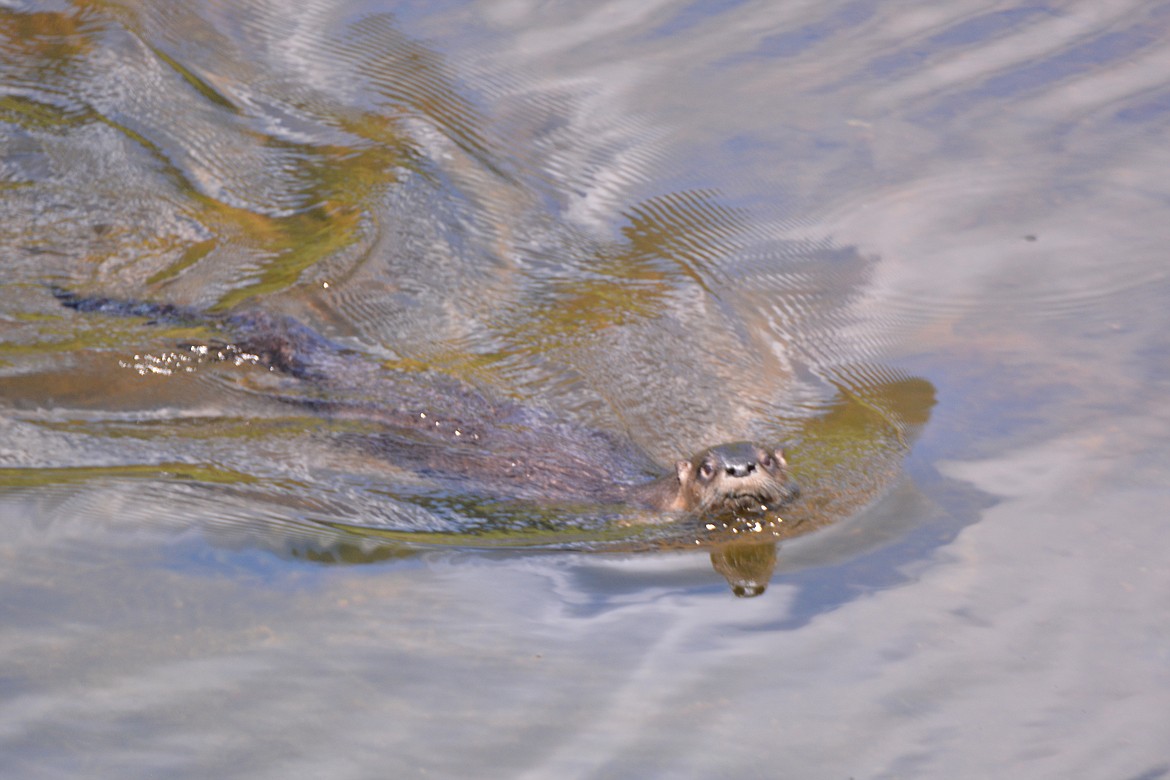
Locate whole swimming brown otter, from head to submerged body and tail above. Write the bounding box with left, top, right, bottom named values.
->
left=53, top=288, right=798, bottom=517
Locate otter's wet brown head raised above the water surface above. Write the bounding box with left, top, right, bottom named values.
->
left=675, top=442, right=797, bottom=516
